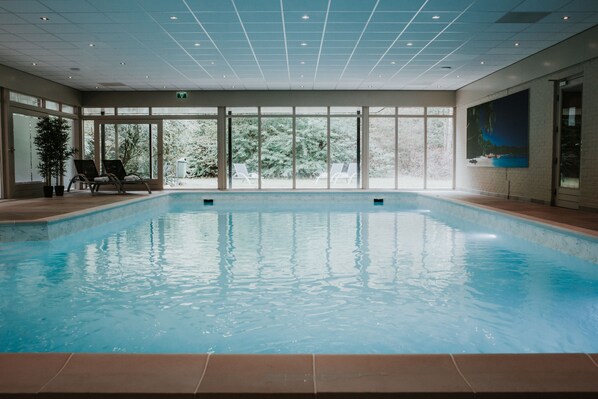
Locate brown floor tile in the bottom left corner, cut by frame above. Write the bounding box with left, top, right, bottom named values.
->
left=0, top=353, right=70, bottom=397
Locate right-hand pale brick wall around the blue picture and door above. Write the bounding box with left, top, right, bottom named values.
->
left=455, top=28, right=598, bottom=209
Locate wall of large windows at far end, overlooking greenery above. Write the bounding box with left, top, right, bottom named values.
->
left=77, top=107, right=454, bottom=189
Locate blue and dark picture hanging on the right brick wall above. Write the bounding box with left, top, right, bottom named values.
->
left=467, top=90, right=529, bottom=168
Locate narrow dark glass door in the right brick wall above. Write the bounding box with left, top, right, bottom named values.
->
left=554, top=79, right=583, bottom=209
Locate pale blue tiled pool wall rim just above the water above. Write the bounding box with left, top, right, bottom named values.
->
left=0, top=191, right=598, bottom=264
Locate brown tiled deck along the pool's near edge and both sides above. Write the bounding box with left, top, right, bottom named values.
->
left=0, top=192, right=598, bottom=399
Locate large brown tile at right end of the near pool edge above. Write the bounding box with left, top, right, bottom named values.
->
left=454, top=354, right=598, bottom=398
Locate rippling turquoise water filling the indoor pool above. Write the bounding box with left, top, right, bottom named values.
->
left=0, top=195, right=598, bottom=353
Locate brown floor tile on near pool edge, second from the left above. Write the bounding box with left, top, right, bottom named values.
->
left=42, top=354, right=207, bottom=398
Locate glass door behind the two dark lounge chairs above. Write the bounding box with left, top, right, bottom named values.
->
left=94, top=121, right=163, bottom=189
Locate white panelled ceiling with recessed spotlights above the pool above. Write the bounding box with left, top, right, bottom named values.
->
left=0, top=0, right=598, bottom=91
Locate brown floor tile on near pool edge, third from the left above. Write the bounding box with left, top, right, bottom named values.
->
left=197, top=355, right=314, bottom=398
